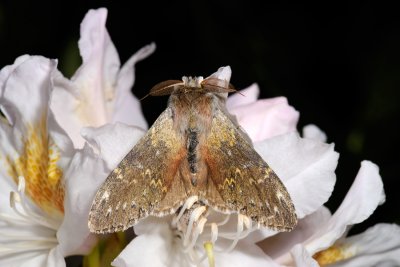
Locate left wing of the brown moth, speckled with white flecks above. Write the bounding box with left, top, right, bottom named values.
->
left=88, top=108, right=186, bottom=233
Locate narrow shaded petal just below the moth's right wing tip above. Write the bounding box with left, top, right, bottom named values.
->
left=258, top=206, right=331, bottom=264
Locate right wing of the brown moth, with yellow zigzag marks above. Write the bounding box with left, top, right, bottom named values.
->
left=202, top=108, right=297, bottom=231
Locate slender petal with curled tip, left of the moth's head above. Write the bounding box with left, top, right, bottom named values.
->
left=112, top=43, right=156, bottom=129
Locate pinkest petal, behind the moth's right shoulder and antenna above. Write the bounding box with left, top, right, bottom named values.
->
left=227, top=88, right=299, bottom=142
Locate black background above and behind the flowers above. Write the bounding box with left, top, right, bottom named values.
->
left=0, top=1, right=400, bottom=245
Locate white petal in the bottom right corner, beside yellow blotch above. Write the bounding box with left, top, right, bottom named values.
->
left=329, top=223, right=400, bottom=267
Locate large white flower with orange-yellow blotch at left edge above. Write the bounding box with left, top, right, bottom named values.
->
left=0, top=56, right=106, bottom=266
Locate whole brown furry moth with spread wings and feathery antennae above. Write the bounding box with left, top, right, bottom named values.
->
left=88, top=77, right=297, bottom=233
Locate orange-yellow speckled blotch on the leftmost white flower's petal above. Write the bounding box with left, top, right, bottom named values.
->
left=6, top=119, right=65, bottom=214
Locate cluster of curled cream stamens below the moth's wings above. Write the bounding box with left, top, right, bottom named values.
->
left=171, top=196, right=258, bottom=267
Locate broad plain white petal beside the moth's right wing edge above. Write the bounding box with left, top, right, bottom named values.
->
left=255, top=133, right=339, bottom=218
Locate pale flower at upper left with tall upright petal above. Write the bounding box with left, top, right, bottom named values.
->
left=51, top=8, right=155, bottom=148
